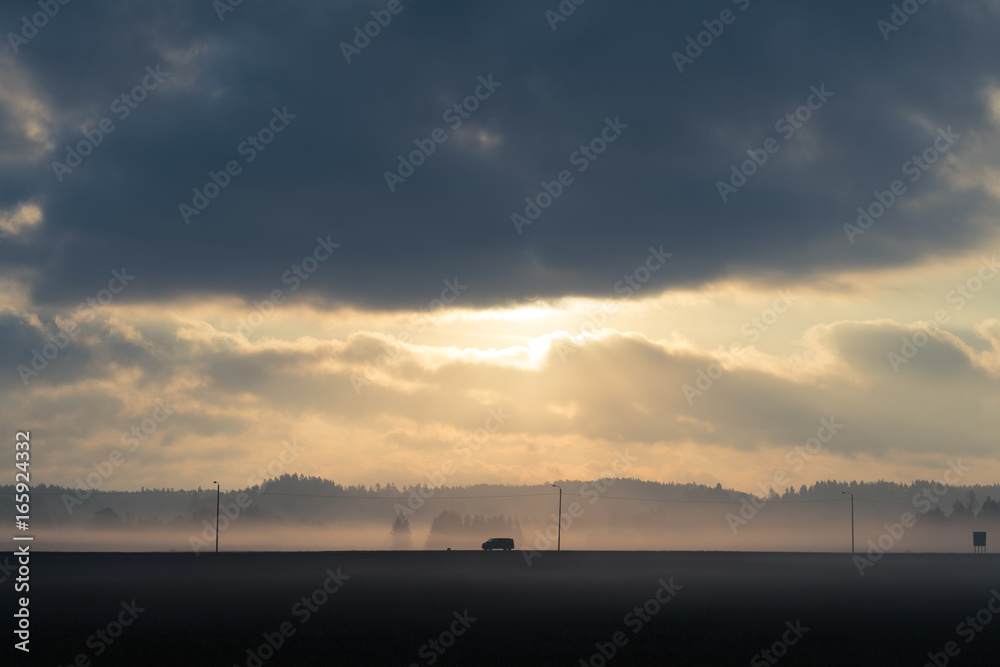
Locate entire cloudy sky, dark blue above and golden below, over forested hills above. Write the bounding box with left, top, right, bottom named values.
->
left=0, top=0, right=1000, bottom=491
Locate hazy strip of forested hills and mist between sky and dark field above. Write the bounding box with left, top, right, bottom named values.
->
left=9, top=475, right=1000, bottom=553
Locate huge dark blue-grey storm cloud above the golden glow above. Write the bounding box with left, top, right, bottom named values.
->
left=0, top=0, right=1000, bottom=308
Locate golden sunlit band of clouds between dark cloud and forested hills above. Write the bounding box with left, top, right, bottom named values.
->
left=4, top=240, right=1000, bottom=490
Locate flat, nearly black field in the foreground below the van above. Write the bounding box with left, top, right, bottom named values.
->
left=4, top=551, right=1000, bottom=667
